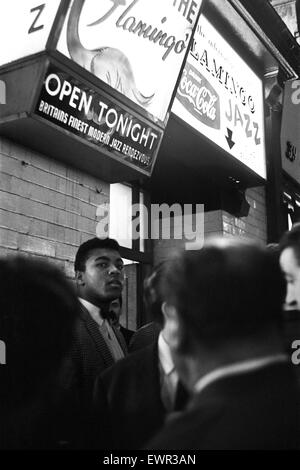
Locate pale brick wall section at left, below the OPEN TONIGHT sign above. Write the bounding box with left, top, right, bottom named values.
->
left=0, top=138, right=109, bottom=277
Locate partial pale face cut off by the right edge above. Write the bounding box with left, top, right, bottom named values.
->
left=280, top=248, right=300, bottom=310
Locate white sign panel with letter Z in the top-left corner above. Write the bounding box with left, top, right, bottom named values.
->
left=0, top=0, right=61, bottom=66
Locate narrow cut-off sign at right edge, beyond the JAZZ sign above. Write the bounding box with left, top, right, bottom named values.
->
left=281, top=80, right=300, bottom=183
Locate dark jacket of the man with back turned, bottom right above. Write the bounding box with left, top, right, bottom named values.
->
left=147, top=364, right=299, bottom=450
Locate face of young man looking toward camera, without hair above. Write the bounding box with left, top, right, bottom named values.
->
left=77, top=248, right=124, bottom=305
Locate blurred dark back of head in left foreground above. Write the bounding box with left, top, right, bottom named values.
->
left=0, top=257, right=80, bottom=409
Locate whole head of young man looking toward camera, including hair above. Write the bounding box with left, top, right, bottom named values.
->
left=75, top=238, right=124, bottom=306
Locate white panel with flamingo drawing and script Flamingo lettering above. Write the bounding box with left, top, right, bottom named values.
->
left=57, top=0, right=202, bottom=122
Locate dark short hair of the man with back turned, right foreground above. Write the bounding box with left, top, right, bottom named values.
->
left=163, top=239, right=285, bottom=344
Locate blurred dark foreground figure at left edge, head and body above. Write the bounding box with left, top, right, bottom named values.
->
left=0, top=257, right=79, bottom=449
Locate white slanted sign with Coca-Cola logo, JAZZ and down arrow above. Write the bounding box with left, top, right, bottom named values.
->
left=172, top=15, right=266, bottom=179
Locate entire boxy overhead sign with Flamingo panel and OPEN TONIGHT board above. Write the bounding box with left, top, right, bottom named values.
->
left=0, top=0, right=204, bottom=182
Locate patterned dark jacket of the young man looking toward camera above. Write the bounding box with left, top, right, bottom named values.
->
left=51, top=305, right=126, bottom=449
